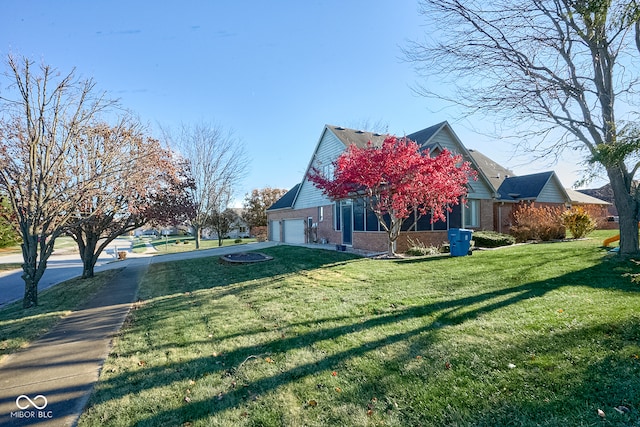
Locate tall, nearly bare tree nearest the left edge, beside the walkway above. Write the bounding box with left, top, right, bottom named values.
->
left=0, top=56, right=110, bottom=308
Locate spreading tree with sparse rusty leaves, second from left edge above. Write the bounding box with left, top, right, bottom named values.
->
left=68, top=116, right=191, bottom=278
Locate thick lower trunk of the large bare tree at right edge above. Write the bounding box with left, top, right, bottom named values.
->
left=607, top=168, right=638, bottom=255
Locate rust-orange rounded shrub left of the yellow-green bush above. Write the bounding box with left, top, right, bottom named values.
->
left=510, top=202, right=566, bottom=242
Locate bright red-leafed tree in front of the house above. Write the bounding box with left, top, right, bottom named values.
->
left=309, top=136, right=475, bottom=256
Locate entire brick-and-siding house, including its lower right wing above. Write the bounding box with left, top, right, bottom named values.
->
left=267, top=122, right=601, bottom=252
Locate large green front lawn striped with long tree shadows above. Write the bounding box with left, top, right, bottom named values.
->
left=79, top=232, right=640, bottom=426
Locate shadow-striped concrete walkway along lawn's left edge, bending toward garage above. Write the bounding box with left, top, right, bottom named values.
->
left=0, top=242, right=276, bottom=427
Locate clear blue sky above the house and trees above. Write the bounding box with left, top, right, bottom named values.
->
left=0, top=0, right=596, bottom=203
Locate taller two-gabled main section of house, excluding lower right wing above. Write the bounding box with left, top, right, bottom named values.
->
left=267, top=122, right=495, bottom=251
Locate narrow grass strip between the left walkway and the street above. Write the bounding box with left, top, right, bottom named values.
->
left=0, top=269, right=119, bottom=361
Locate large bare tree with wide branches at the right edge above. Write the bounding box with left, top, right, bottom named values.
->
left=405, top=0, right=640, bottom=254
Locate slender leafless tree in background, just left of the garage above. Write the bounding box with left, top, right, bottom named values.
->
left=164, top=123, right=249, bottom=249
